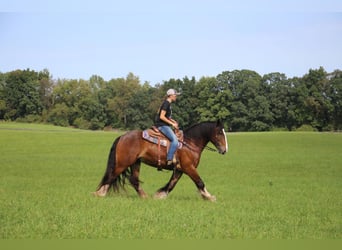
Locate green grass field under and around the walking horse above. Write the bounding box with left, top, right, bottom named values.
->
left=0, top=122, right=342, bottom=239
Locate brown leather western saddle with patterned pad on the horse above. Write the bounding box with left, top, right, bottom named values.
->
left=142, top=126, right=184, bottom=170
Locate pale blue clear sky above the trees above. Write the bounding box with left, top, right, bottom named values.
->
left=0, top=0, right=342, bottom=85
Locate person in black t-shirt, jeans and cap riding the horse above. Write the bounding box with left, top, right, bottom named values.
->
left=154, top=89, right=180, bottom=168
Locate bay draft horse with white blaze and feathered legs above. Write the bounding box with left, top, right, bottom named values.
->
left=93, top=121, right=228, bottom=201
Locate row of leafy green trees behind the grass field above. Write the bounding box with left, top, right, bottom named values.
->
left=0, top=67, right=342, bottom=131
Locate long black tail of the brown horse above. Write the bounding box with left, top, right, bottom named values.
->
left=97, top=136, right=129, bottom=191
